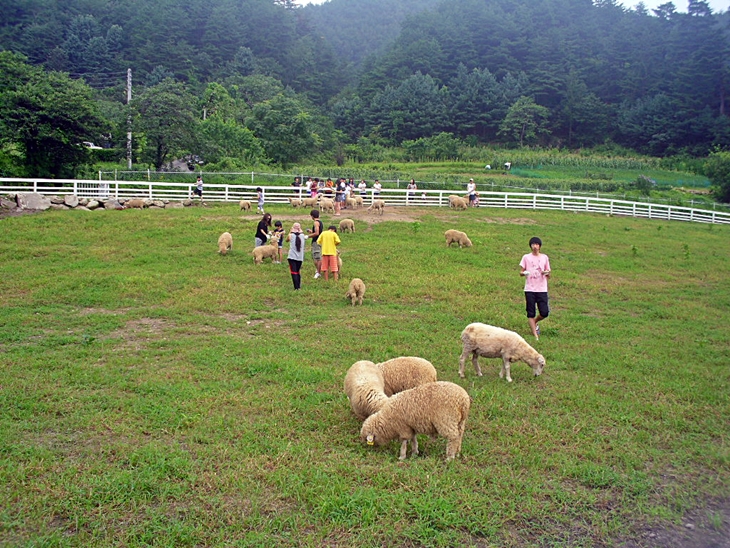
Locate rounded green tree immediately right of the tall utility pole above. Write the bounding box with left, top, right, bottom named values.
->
left=131, top=78, right=198, bottom=170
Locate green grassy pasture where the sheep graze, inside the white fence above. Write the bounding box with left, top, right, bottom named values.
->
left=0, top=205, right=730, bottom=547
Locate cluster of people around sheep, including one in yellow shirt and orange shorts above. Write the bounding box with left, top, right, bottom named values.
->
left=254, top=209, right=341, bottom=291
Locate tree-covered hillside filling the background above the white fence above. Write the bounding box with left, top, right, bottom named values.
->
left=0, top=0, right=730, bottom=175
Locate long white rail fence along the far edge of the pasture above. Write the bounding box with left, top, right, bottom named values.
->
left=0, top=178, right=730, bottom=224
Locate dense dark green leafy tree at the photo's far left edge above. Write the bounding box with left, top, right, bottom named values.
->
left=0, top=52, right=103, bottom=177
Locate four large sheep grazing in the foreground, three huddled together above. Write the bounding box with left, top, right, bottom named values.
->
left=344, top=323, right=545, bottom=461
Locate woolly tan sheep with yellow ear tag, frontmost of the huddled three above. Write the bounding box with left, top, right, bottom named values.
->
left=360, top=381, right=471, bottom=461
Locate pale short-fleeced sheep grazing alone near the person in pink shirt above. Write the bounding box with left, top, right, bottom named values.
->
left=459, top=323, right=545, bottom=382
